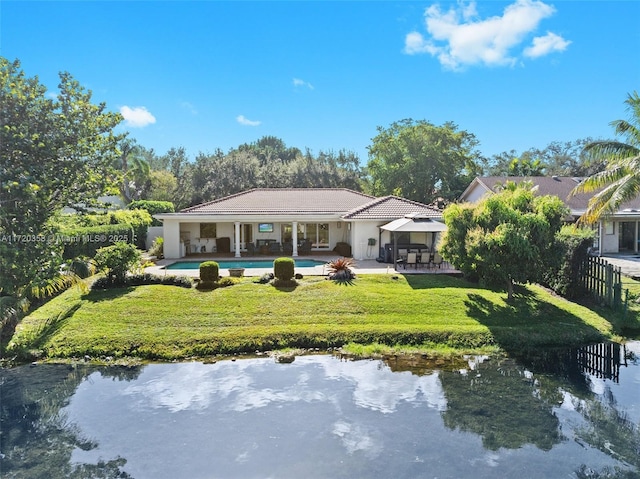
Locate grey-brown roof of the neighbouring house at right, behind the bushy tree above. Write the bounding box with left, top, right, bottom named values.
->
left=460, top=176, right=640, bottom=216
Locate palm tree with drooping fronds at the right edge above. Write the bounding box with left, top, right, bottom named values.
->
left=572, top=91, right=640, bottom=223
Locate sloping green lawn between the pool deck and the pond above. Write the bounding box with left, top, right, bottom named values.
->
left=9, top=275, right=628, bottom=360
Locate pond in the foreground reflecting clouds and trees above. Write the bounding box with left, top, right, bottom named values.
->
left=0, top=341, right=640, bottom=479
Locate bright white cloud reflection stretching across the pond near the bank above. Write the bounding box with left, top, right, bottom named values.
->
left=124, top=356, right=446, bottom=414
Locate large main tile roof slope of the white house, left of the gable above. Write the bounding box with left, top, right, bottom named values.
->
left=181, top=188, right=375, bottom=215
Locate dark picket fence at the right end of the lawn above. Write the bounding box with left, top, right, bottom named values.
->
left=580, top=256, right=623, bottom=310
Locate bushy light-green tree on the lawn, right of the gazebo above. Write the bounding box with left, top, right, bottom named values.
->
left=440, top=182, right=568, bottom=299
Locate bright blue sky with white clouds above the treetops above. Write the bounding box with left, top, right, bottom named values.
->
left=0, top=0, right=640, bottom=164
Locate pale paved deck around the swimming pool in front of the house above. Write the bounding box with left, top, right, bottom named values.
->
left=145, top=255, right=460, bottom=278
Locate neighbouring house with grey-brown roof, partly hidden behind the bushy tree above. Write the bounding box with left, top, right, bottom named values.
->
left=460, top=176, right=640, bottom=254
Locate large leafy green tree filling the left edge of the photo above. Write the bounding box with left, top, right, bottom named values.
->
left=0, top=57, right=122, bottom=318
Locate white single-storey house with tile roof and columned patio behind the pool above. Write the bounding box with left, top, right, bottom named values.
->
left=155, top=188, right=442, bottom=259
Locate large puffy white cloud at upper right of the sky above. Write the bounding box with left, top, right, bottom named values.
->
left=404, top=0, right=569, bottom=70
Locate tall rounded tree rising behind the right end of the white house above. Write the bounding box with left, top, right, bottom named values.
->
left=367, top=119, right=480, bottom=203
